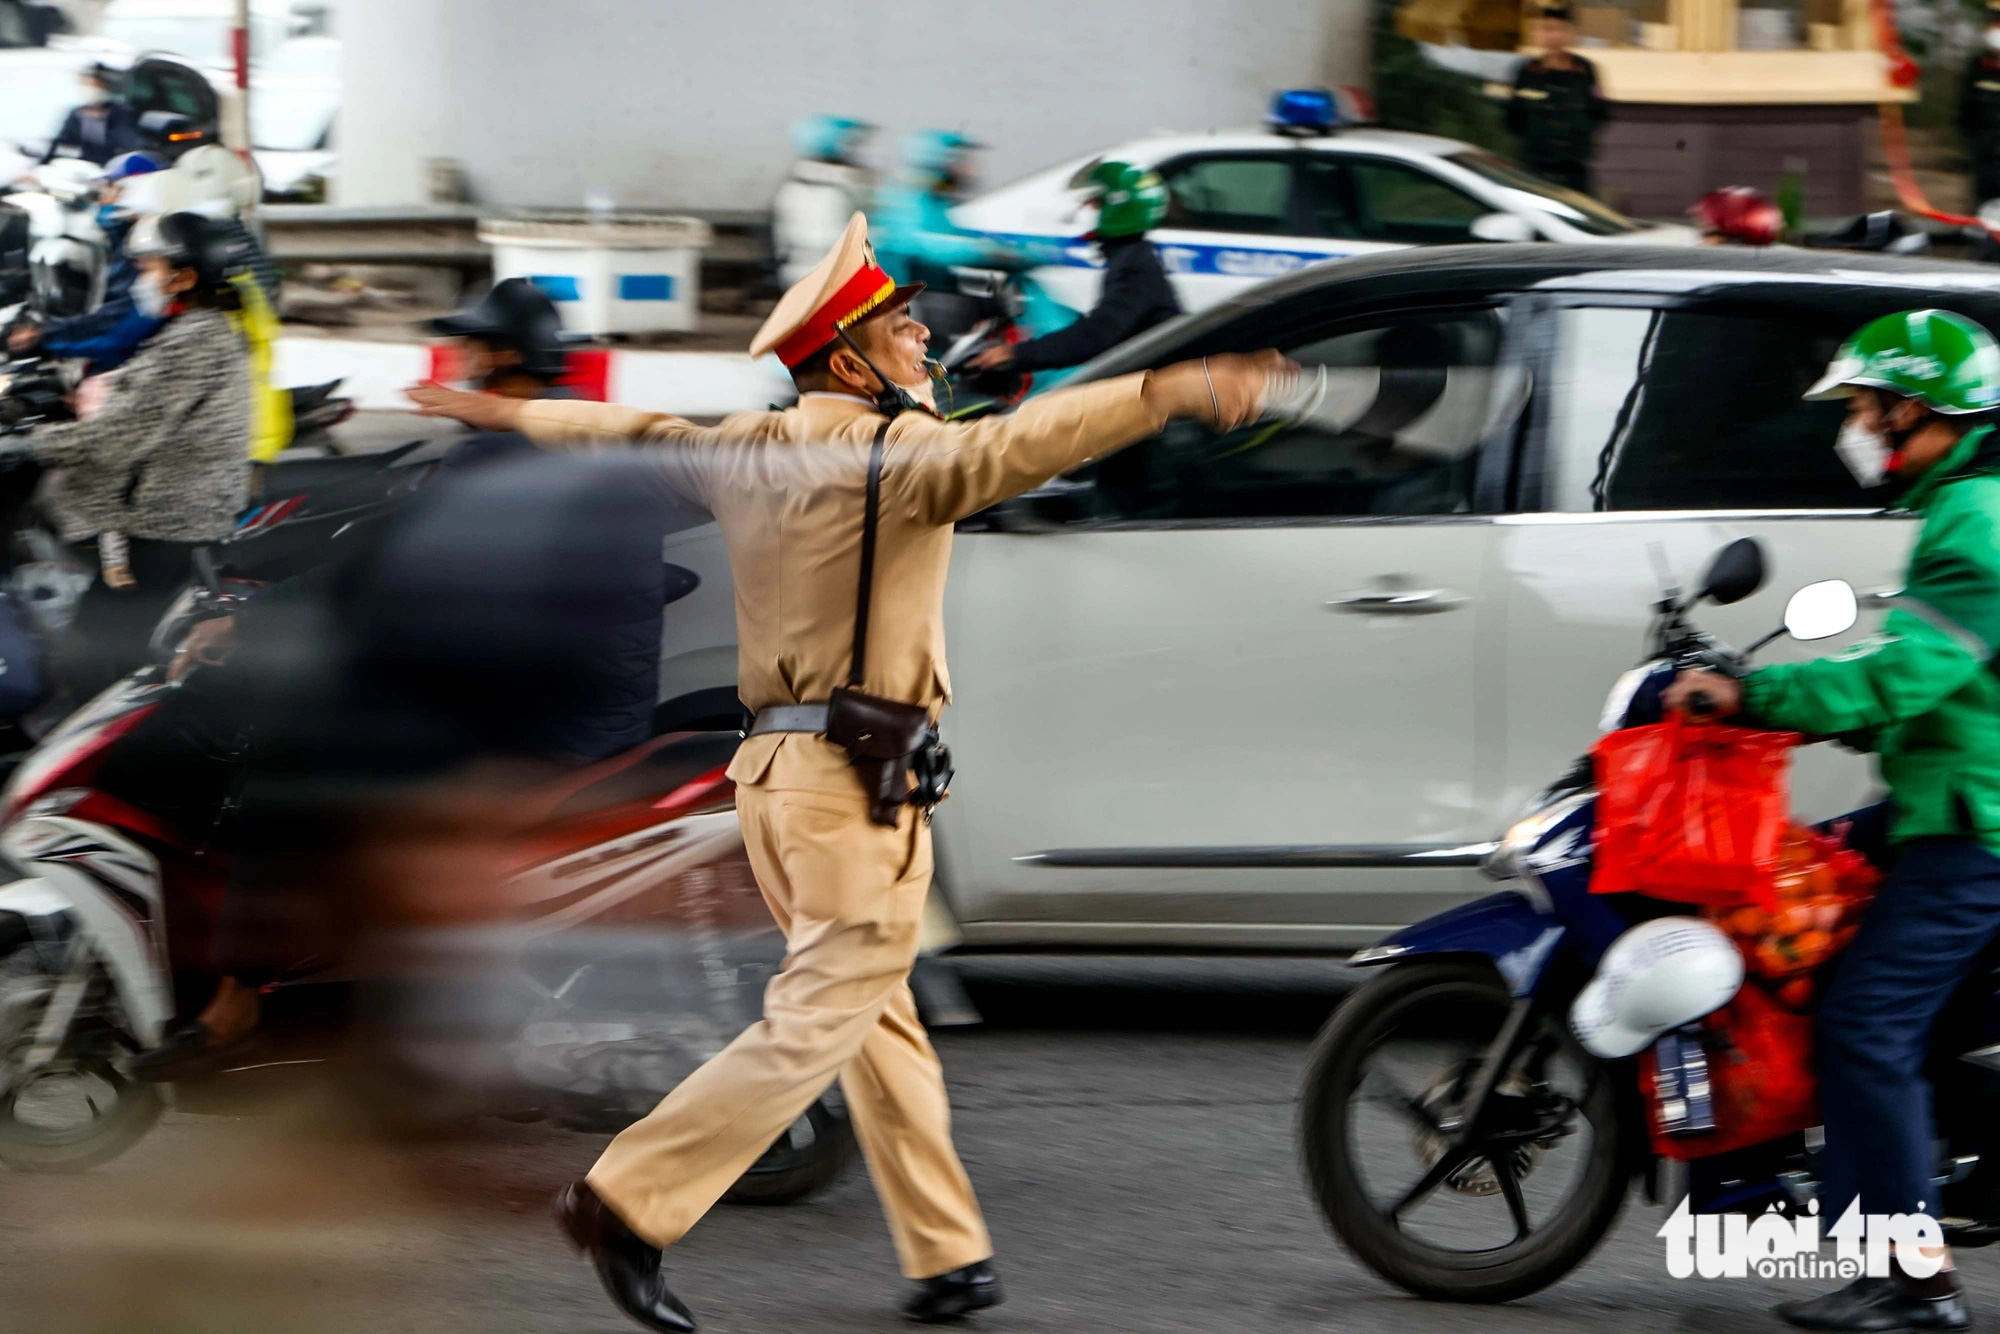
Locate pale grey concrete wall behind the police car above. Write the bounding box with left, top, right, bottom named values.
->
left=338, top=0, right=1368, bottom=208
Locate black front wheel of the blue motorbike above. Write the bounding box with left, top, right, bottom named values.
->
left=1300, top=962, right=1630, bottom=1302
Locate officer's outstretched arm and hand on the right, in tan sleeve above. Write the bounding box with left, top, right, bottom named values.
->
left=884, top=352, right=1286, bottom=524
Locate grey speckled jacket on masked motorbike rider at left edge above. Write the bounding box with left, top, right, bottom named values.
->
left=28, top=310, right=250, bottom=542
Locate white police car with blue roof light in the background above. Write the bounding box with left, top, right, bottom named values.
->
left=952, top=90, right=1698, bottom=310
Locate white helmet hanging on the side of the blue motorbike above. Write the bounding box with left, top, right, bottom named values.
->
left=1570, top=918, right=1744, bottom=1060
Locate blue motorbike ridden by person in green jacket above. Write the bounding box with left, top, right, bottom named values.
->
left=1300, top=538, right=2000, bottom=1302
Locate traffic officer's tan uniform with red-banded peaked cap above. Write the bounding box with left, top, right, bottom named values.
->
left=520, top=214, right=1166, bottom=1278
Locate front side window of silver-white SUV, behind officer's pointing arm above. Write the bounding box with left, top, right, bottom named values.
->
left=1084, top=310, right=1526, bottom=520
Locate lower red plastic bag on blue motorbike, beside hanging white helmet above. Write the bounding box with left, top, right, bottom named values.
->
left=1638, top=980, right=1820, bottom=1162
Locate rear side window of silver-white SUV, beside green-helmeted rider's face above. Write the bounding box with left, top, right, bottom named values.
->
left=1548, top=306, right=1876, bottom=510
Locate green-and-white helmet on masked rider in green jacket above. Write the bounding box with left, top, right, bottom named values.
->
left=1806, top=310, right=2000, bottom=414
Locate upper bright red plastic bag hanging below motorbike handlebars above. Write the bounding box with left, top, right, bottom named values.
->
left=1590, top=714, right=1798, bottom=908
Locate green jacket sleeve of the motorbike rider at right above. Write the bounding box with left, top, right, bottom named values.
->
left=1744, top=482, right=2000, bottom=736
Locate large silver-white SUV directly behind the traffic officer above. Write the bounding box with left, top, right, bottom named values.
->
left=662, top=246, right=2000, bottom=948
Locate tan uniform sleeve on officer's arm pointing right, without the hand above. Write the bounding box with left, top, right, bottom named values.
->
left=882, top=374, right=1166, bottom=524
